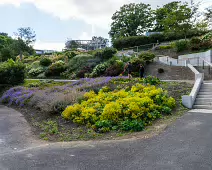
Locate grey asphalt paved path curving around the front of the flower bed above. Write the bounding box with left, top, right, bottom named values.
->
left=0, top=107, right=212, bottom=170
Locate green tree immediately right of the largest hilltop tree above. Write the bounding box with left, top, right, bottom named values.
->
left=154, top=1, right=198, bottom=38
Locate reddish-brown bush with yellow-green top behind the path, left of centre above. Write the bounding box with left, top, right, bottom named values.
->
left=45, top=60, right=66, bottom=77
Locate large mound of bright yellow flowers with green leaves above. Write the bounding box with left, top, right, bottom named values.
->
left=62, top=84, right=175, bottom=132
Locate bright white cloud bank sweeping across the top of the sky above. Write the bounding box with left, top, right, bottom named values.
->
left=0, top=0, right=212, bottom=30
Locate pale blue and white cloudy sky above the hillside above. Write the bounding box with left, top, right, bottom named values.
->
left=0, top=0, right=212, bottom=51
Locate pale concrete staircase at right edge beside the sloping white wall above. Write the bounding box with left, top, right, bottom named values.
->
left=193, top=82, right=212, bottom=110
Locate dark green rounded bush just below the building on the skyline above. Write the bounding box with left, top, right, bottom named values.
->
left=94, top=47, right=117, bottom=60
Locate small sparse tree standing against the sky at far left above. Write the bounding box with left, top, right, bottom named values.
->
left=15, top=27, right=36, bottom=46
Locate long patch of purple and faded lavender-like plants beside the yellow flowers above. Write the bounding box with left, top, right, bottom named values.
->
left=0, top=77, right=126, bottom=114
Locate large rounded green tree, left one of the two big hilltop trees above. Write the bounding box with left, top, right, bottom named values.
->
left=109, top=3, right=154, bottom=39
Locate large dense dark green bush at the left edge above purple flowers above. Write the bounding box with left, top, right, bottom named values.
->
left=0, top=59, right=25, bottom=85
